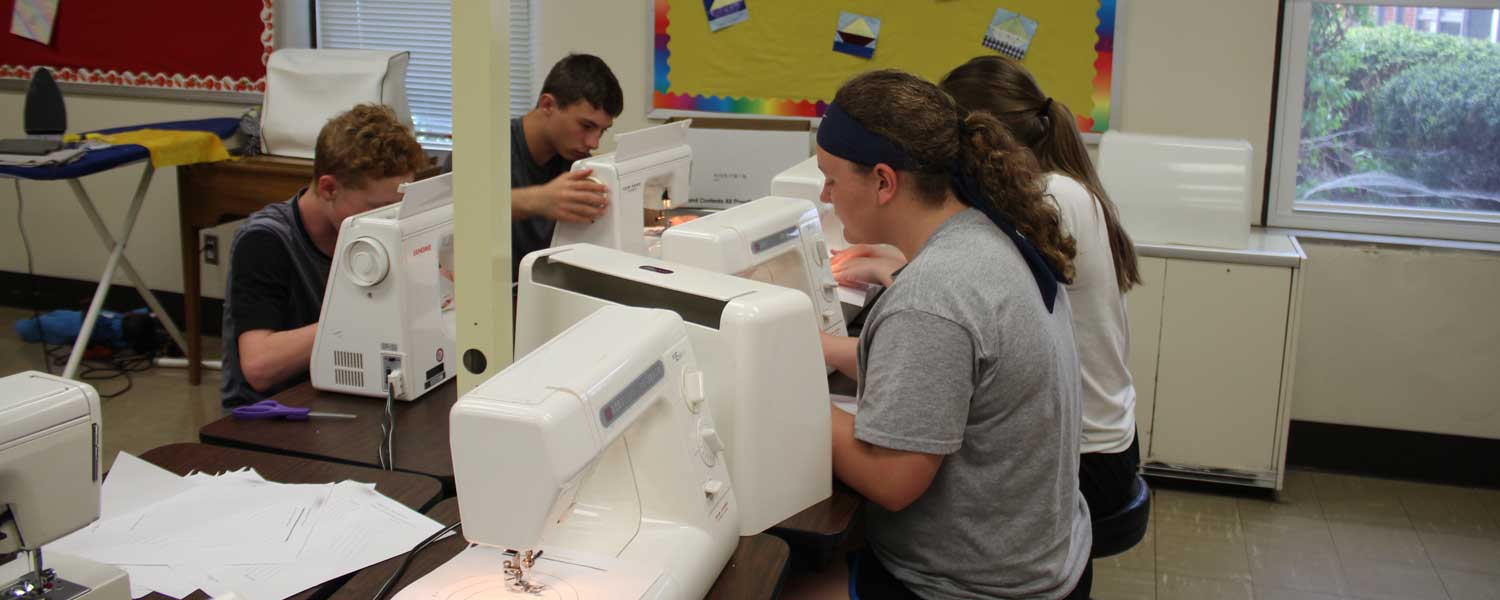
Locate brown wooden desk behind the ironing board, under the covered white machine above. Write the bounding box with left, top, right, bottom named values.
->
left=177, top=156, right=312, bottom=386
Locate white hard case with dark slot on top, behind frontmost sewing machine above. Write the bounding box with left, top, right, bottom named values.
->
left=516, top=245, right=833, bottom=536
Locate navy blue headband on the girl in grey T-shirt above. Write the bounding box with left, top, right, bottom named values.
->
left=818, top=104, right=1062, bottom=312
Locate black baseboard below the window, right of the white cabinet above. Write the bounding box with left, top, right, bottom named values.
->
left=1287, top=420, right=1500, bottom=488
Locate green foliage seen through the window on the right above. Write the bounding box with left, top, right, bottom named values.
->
left=1298, top=3, right=1500, bottom=210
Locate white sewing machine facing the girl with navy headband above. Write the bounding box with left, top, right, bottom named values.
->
left=662, top=197, right=849, bottom=336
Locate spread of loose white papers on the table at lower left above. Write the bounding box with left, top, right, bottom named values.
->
left=45, top=453, right=443, bottom=600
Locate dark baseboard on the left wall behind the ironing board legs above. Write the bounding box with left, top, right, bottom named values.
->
left=0, top=272, right=224, bottom=337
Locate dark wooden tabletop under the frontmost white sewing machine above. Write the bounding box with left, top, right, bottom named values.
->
left=329, top=498, right=791, bottom=600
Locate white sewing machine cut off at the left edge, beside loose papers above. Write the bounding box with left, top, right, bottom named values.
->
left=0, top=371, right=131, bottom=600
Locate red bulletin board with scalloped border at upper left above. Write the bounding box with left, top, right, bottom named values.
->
left=0, top=0, right=273, bottom=92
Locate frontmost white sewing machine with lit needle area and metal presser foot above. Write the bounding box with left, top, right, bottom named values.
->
left=450, top=306, right=741, bottom=599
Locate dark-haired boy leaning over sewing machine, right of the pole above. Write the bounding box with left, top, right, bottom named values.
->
left=510, top=54, right=626, bottom=281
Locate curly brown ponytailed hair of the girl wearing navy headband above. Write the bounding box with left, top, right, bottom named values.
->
left=834, top=69, right=1077, bottom=284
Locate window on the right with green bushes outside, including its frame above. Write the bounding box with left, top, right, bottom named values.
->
left=1271, top=0, right=1500, bottom=242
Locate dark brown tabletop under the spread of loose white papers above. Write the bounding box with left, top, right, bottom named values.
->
left=141, top=441, right=441, bottom=600
